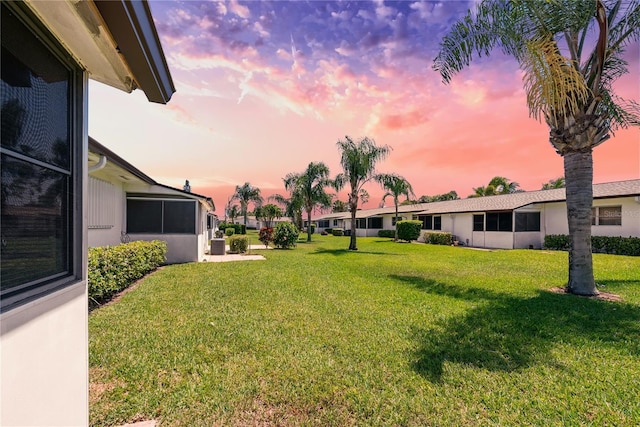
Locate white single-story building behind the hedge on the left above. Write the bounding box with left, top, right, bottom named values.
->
left=87, top=137, right=215, bottom=264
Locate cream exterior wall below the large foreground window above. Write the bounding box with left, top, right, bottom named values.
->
left=0, top=281, right=89, bottom=426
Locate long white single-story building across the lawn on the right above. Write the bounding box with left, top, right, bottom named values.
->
left=315, top=179, right=640, bottom=249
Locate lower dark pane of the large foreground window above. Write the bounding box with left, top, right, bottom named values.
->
left=0, top=155, right=70, bottom=292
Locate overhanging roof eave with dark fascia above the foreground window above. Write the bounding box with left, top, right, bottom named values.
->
left=25, top=0, right=176, bottom=104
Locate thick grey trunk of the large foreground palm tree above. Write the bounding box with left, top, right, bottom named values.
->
left=564, top=150, right=598, bottom=295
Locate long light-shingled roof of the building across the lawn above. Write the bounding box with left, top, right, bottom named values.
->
left=316, top=179, right=640, bottom=220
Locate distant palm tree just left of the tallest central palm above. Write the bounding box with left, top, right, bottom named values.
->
left=284, top=162, right=332, bottom=242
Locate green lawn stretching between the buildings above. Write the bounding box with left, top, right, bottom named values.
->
left=89, top=235, right=640, bottom=426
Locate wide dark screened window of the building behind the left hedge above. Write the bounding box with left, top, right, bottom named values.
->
left=127, top=198, right=196, bottom=234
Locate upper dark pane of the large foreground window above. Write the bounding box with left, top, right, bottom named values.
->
left=0, top=8, right=71, bottom=171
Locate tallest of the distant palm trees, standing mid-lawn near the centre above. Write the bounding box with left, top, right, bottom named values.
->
left=334, top=136, right=391, bottom=251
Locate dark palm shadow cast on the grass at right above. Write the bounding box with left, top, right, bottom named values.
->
left=392, top=276, right=640, bottom=382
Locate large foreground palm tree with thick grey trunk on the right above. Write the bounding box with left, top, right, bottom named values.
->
left=433, top=0, right=640, bottom=295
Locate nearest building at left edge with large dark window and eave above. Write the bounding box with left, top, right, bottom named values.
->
left=0, top=0, right=175, bottom=426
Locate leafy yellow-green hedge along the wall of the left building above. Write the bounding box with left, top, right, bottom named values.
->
left=88, top=240, right=167, bottom=307
